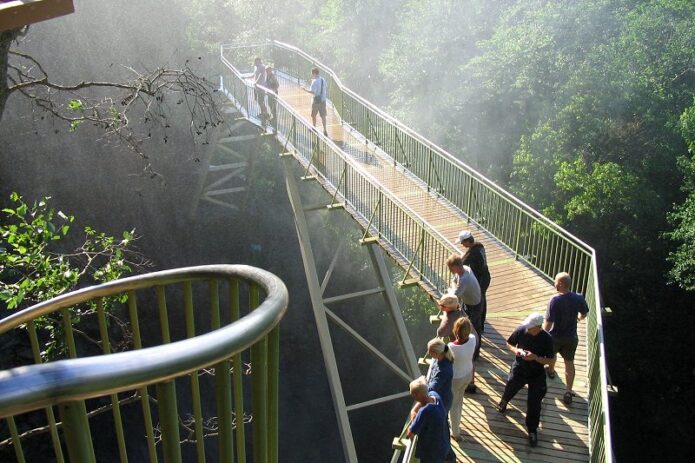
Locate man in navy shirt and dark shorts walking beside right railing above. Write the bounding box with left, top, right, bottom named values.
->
left=543, top=272, right=589, bottom=405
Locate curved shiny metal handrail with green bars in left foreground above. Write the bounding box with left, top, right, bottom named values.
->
left=0, top=265, right=288, bottom=462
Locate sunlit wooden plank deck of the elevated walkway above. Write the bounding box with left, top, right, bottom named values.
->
left=280, top=74, right=589, bottom=462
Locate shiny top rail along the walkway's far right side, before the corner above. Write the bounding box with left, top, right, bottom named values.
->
left=264, top=40, right=593, bottom=253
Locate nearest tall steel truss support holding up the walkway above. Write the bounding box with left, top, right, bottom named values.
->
left=281, top=154, right=420, bottom=463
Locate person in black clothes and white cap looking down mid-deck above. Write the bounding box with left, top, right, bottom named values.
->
left=497, top=312, right=553, bottom=447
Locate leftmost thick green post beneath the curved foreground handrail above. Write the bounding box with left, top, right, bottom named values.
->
left=58, top=400, right=96, bottom=463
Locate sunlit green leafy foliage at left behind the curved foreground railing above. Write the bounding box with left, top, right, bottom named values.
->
left=0, top=193, right=140, bottom=358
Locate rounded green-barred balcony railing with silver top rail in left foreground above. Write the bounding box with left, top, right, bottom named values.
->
left=0, top=265, right=288, bottom=463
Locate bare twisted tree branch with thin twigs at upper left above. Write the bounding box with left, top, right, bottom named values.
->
left=0, top=46, right=223, bottom=176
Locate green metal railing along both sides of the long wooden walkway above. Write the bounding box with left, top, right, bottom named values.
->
left=220, top=42, right=613, bottom=462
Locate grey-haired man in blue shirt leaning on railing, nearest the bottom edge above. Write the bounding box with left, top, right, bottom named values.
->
left=407, top=378, right=455, bottom=463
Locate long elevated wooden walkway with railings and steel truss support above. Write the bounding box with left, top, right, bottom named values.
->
left=221, top=42, right=613, bottom=462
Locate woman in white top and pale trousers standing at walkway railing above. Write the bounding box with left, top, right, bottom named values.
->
left=448, top=317, right=475, bottom=441
